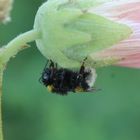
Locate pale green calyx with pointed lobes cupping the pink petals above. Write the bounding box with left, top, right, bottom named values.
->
left=34, top=0, right=132, bottom=68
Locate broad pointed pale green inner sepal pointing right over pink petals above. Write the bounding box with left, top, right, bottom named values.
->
left=64, top=13, right=132, bottom=60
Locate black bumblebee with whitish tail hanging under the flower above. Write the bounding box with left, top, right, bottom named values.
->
left=40, top=60, right=96, bottom=95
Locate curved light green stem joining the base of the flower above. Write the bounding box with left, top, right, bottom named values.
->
left=0, top=30, right=41, bottom=140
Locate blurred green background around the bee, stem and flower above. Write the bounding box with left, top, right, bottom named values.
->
left=0, top=0, right=140, bottom=140
